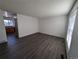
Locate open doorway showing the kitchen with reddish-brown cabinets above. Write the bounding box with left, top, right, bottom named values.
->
left=3, top=11, right=18, bottom=44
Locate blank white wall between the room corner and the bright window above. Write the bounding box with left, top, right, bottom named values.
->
left=39, top=16, right=67, bottom=38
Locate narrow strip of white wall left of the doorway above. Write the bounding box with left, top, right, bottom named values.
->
left=0, top=10, right=7, bottom=43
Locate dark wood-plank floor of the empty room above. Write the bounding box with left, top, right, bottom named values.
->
left=0, top=33, right=66, bottom=59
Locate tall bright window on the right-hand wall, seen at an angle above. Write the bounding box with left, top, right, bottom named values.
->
left=67, top=10, right=77, bottom=50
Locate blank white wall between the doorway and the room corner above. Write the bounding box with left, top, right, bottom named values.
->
left=17, top=14, right=39, bottom=37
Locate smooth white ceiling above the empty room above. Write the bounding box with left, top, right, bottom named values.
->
left=0, top=0, right=75, bottom=17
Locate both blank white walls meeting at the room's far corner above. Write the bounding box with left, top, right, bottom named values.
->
left=17, top=14, right=67, bottom=38
